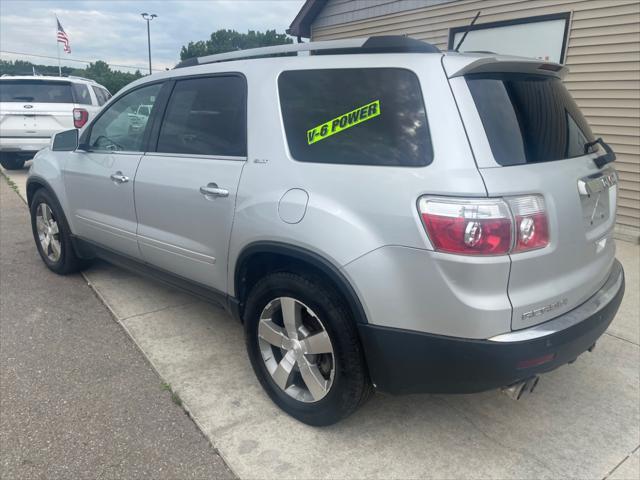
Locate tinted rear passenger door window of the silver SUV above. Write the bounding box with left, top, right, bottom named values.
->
left=157, top=76, right=247, bottom=156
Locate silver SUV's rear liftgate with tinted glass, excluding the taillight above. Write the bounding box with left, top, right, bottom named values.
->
left=451, top=60, right=617, bottom=329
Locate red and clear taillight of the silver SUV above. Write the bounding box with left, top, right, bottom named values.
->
left=418, top=195, right=549, bottom=255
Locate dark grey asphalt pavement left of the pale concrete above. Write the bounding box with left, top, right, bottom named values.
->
left=0, top=176, right=233, bottom=479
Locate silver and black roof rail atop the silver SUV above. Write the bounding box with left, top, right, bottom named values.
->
left=175, top=35, right=440, bottom=68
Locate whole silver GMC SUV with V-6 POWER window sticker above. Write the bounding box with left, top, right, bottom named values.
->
left=27, top=37, right=624, bottom=425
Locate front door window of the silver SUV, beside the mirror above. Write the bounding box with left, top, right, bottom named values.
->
left=89, top=83, right=162, bottom=152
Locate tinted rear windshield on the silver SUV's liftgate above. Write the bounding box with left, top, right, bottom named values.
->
left=466, top=73, right=594, bottom=165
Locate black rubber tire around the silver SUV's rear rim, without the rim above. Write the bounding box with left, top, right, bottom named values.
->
left=244, top=272, right=373, bottom=426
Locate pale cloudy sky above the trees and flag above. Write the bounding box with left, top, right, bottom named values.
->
left=0, top=0, right=304, bottom=73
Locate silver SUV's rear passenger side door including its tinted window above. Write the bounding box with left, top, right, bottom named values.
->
left=135, top=75, right=247, bottom=292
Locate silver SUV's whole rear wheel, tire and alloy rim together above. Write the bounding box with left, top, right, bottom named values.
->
left=244, top=272, right=372, bottom=426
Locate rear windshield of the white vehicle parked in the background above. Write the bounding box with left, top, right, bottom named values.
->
left=0, top=80, right=75, bottom=103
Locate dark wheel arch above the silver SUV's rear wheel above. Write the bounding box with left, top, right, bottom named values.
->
left=233, top=242, right=368, bottom=323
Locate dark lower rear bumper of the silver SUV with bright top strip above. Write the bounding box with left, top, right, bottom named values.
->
left=358, top=260, right=625, bottom=394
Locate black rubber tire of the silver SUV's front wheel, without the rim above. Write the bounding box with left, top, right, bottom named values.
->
left=30, top=188, right=88, bottom=275
